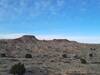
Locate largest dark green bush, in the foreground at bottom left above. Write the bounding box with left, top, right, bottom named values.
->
left=10, top=63, right=26, bottom=75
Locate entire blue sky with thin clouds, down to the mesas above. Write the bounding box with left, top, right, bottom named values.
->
left=0, top=0, right=100, bottom=43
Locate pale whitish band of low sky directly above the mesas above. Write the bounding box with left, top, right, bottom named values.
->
left=0, top=33, right=100, bottom=44
